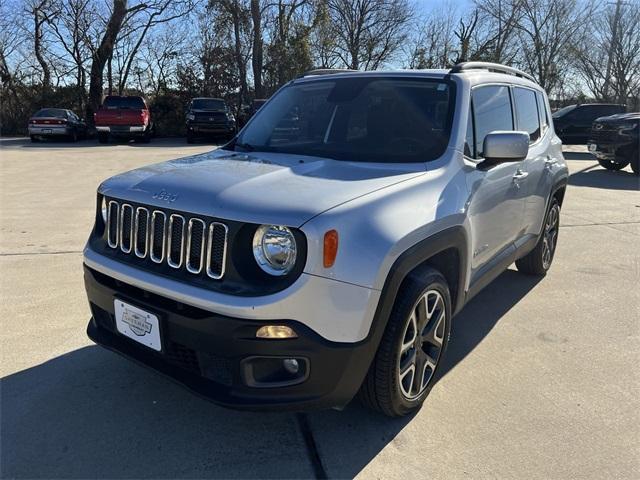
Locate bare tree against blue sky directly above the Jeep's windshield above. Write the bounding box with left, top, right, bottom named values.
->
left=328, top=0, right=412, bottom=70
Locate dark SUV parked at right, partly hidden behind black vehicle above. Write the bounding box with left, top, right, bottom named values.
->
left=553, top=103, right=626, bottom=145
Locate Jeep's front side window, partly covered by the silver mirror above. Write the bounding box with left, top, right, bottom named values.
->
left=472, top=85, right=514, bottom=156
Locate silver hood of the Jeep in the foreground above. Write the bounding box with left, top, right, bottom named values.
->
left=99, top=150, right=425, bottom=227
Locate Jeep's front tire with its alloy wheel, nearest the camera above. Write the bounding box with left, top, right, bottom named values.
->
left=358, top=267, right=451, bottom=417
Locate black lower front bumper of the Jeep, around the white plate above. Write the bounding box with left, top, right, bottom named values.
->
left=84, top=265, right=375, bottom=410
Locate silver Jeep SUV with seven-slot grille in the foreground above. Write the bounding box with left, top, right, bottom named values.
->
left=84, top=63, right=567, bottom=416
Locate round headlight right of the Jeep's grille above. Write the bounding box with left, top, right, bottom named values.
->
left=253, top=225, right=297, bottom=276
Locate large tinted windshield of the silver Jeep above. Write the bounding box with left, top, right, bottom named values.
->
left=227, top=77, right=455, bottom=163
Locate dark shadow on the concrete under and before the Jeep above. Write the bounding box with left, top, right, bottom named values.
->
left=0, top=270, right=539, bottom=478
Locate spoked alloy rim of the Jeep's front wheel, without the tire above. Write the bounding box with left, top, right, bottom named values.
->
left=397, top=290, right=447, bottom=400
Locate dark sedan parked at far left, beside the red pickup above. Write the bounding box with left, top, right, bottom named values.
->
left=28, top=108, right=87, bottom=142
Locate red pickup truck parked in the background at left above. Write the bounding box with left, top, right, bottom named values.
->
left=93, top=95, right=153, bottom=143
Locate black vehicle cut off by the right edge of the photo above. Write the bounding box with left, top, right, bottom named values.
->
left=589, top=112, right=640, bottom=175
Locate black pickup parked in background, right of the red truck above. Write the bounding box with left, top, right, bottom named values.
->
left=187, top=98, right=236, bottom=143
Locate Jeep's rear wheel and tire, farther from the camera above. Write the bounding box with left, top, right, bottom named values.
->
left=516, top=197, right=560, bottom=275
